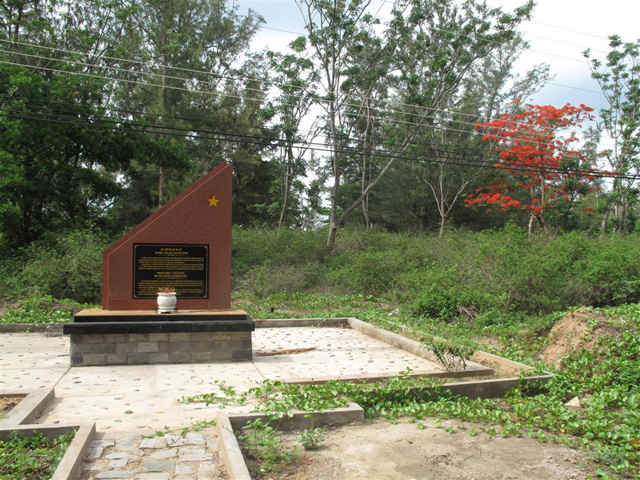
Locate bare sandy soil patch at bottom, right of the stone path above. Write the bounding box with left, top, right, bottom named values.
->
left=272, top=419, right=593, bottom=480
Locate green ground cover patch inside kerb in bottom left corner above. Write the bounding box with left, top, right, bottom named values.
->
left=0, top=432, right=74, bottom=480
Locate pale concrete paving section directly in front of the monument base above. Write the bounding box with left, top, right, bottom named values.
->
left=38, top=362, right=263, bottom=433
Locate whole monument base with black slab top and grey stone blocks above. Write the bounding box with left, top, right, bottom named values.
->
left=63, top=309, right=255, bottom=366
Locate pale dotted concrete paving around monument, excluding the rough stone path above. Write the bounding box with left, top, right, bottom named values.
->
left=0, top=328, right=450, bottom=433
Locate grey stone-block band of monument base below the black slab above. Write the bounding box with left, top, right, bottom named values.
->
left=71, top=331, right=252, bottom=366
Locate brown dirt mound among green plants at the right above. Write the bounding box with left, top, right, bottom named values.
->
left=541, top=310, right=619, bottom=368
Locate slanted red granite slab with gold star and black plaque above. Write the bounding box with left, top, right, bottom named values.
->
left=102, top=164, right=233, bottom=310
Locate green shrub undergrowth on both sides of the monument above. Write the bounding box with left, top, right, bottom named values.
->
left=5, top=225, right=640, bottom=321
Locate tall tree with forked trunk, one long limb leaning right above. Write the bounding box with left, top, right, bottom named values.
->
left=301, top=0, right=533, bottom=250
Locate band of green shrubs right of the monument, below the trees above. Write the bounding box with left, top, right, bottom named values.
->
left=233, top=225, right=640, bottom=318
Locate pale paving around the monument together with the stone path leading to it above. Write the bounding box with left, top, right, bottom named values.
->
left=0, top=328, right=448, bottom=480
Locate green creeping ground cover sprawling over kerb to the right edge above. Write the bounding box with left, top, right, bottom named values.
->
left=185, top=304, right=640, bottom=478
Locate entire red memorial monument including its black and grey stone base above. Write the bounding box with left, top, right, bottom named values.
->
left=63, top=164, right=255, bottom=365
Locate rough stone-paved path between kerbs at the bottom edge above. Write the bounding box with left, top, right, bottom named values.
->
left=81, top=428, right=227, bottom=480
